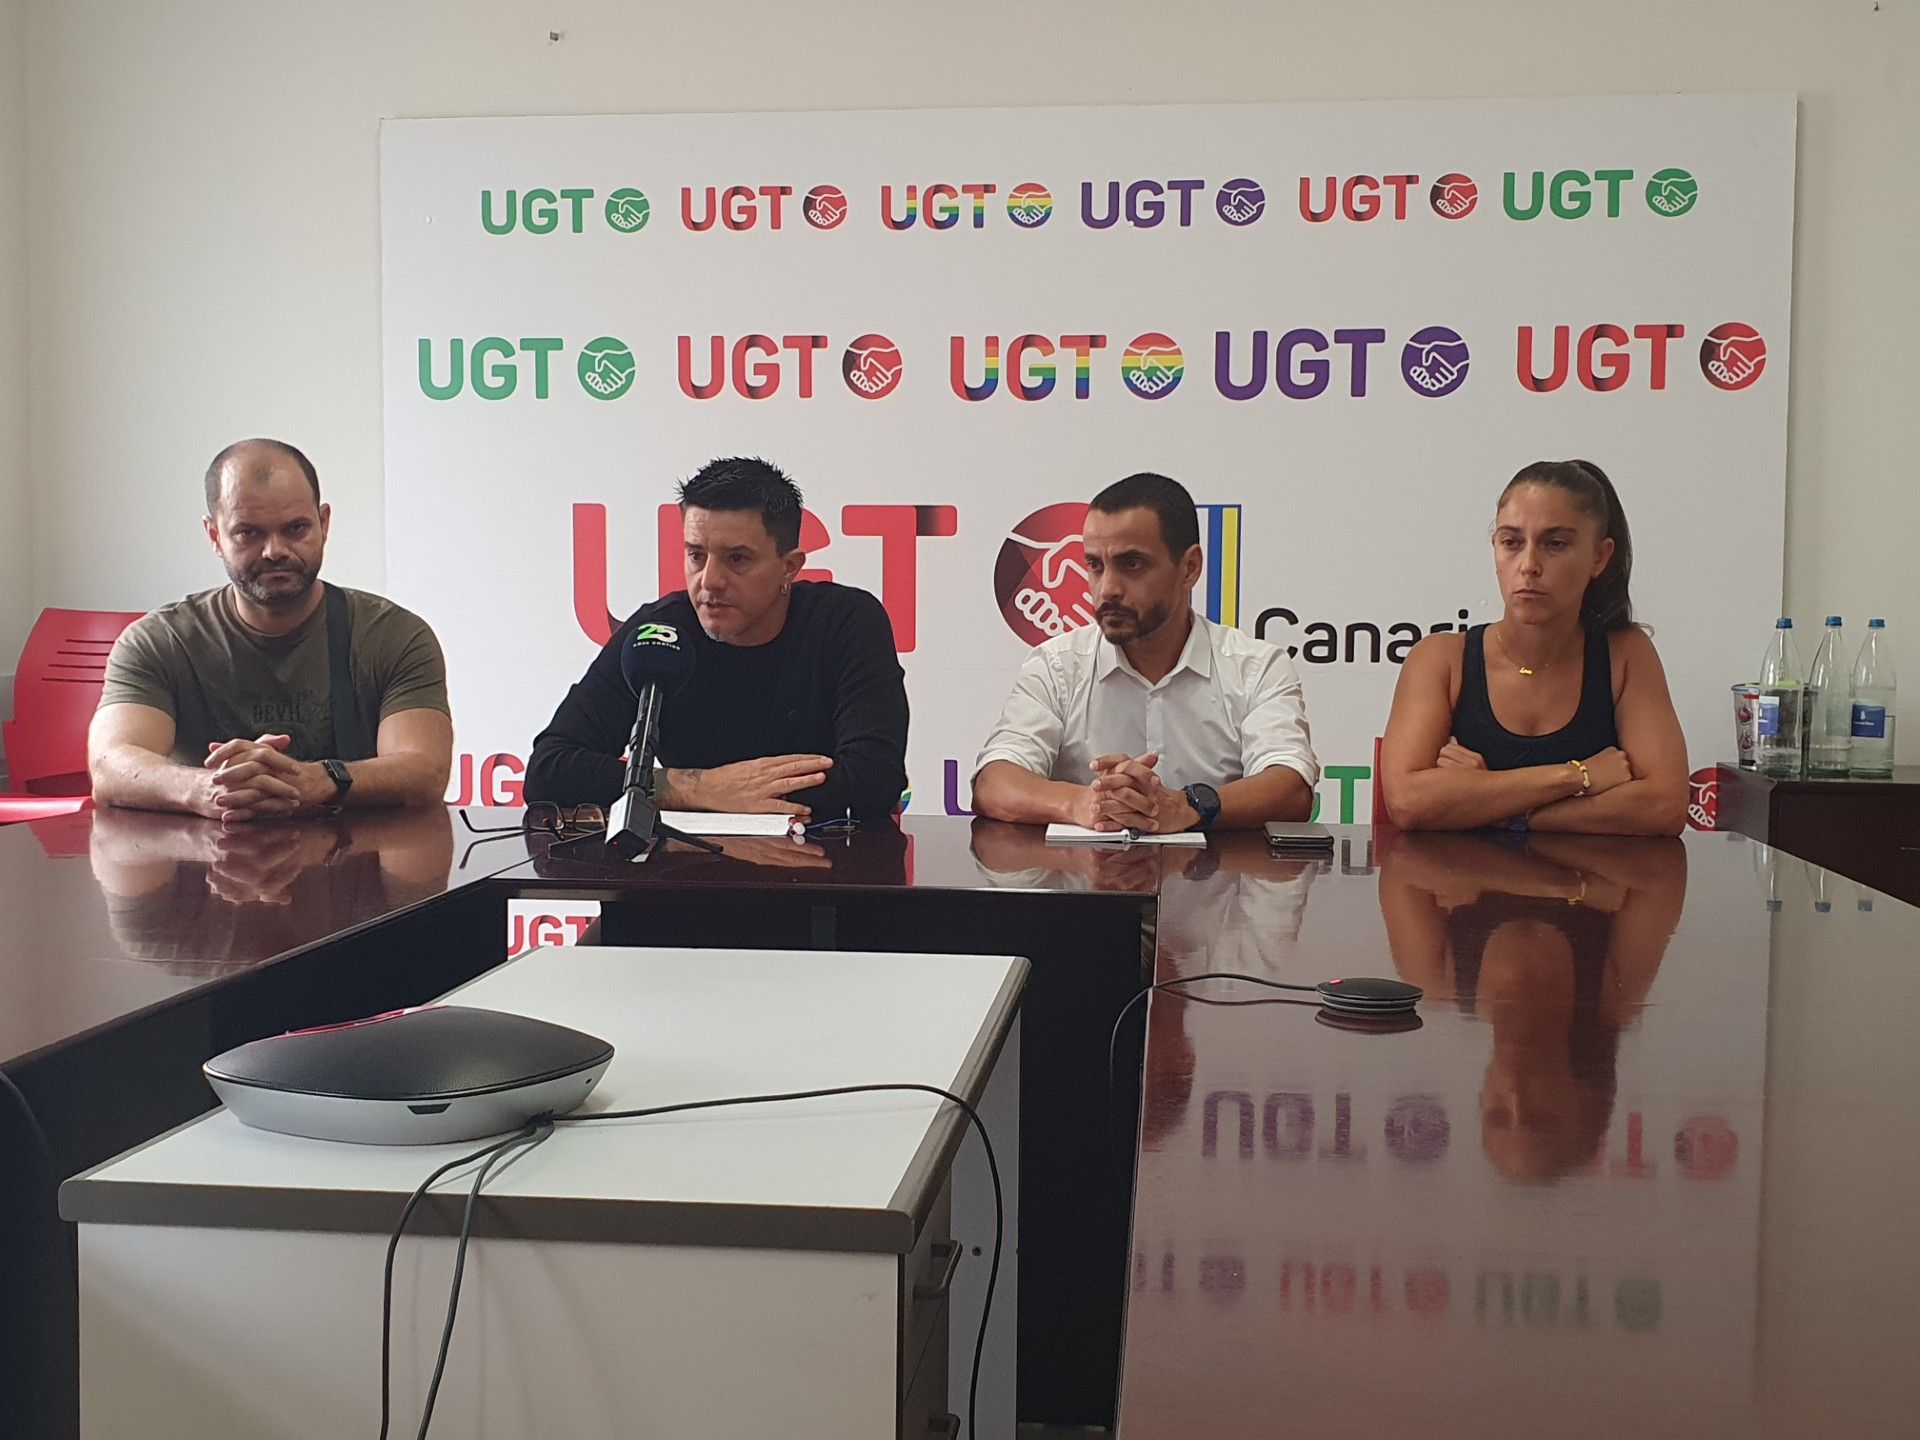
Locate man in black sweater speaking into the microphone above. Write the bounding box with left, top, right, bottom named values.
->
left=526, top=459, right=906, bottom=822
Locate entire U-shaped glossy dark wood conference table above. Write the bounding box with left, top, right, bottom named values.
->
left=11, top=810, right=1920, bottom=1440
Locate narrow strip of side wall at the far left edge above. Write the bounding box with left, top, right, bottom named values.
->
left=0, top=0, right=33, bottom=718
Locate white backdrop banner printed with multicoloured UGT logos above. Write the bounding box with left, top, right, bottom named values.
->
left=380, top=96, right=1795, bottom=820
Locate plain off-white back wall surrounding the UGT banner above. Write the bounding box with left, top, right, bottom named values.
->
left=15, top=0, right=1920, bottom=760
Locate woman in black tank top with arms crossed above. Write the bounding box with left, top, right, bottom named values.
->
left=1379, top=461, right=1688, bottom=835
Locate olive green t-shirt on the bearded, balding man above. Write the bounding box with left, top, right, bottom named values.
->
left=100, top=586, right=449, bottom=764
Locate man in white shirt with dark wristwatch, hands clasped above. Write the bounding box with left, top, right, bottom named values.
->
left=973, top=472, right=1319, bottom=833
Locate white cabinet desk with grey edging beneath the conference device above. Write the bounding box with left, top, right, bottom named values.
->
left=61, top=947, right=1027, bottom=1440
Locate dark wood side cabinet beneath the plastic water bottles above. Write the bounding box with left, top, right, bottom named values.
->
left=1718, top=764, right=1920, bottom=904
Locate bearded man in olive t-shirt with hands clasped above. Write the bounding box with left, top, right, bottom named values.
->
left=86, top=440, right=453, bottom=824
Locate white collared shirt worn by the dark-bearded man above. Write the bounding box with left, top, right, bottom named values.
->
left=973, top=614, right=1319, bottom=802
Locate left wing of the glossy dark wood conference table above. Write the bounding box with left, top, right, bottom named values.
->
left=0, top=810, right=526, bottom=1436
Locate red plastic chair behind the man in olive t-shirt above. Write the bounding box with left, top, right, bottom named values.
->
left=0, top=611, right=140, bottom=820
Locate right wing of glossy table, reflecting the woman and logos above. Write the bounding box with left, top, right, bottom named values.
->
left=1119, top=831, right=1920, bottom=1440
